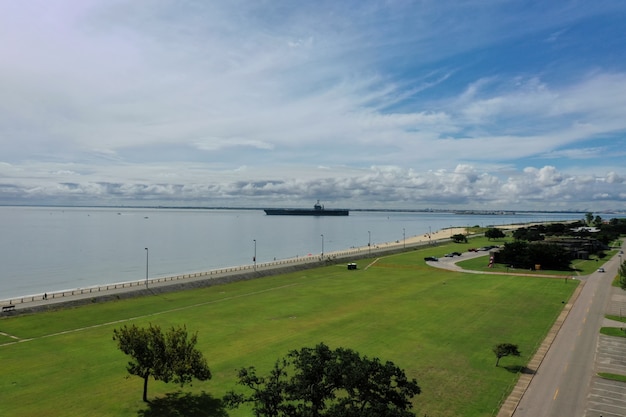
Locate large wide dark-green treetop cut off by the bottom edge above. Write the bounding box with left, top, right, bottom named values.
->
left=224, top=343, right=421, bottom=417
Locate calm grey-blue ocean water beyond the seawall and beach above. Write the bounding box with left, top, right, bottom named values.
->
left=0, top=207, right=583, bottom=299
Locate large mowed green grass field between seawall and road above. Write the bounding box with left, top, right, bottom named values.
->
left=0, top=245, right=578, bottom=417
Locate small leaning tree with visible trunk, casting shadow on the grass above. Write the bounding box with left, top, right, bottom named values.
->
left=113, top=325, right=211, bottom=402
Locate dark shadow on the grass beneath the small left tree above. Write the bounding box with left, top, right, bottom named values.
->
left=137, top=391, right=228, bottom=417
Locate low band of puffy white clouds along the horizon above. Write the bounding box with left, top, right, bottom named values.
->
left=0, top=159, right=625, bottom=210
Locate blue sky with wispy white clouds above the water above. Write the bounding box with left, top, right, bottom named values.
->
left=0, top=0, right=626, bottom=212
